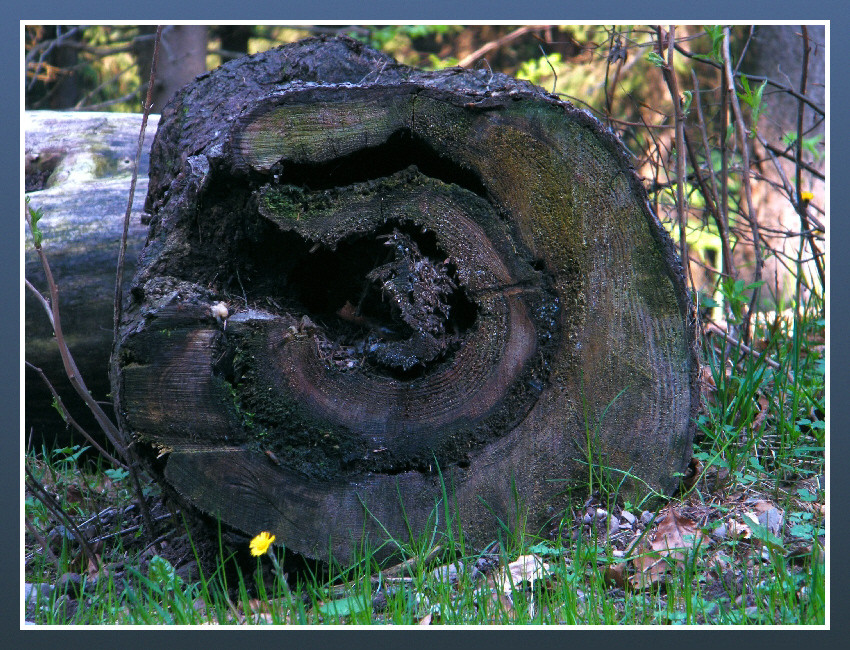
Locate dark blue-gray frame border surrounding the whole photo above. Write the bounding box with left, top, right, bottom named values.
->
left=0, top=0, right=850, bottom=648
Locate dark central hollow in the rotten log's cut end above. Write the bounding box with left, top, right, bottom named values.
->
left=228, top=220, right=477, bottom=379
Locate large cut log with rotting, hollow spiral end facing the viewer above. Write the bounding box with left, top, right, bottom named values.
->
left=111, top=38, right=698, bottom=558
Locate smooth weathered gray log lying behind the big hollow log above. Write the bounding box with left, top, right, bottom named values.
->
left=24, top=111, right=159, bottom=445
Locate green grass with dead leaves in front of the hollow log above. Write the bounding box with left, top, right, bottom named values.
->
left=25, top=246, right=826, bottom=625
